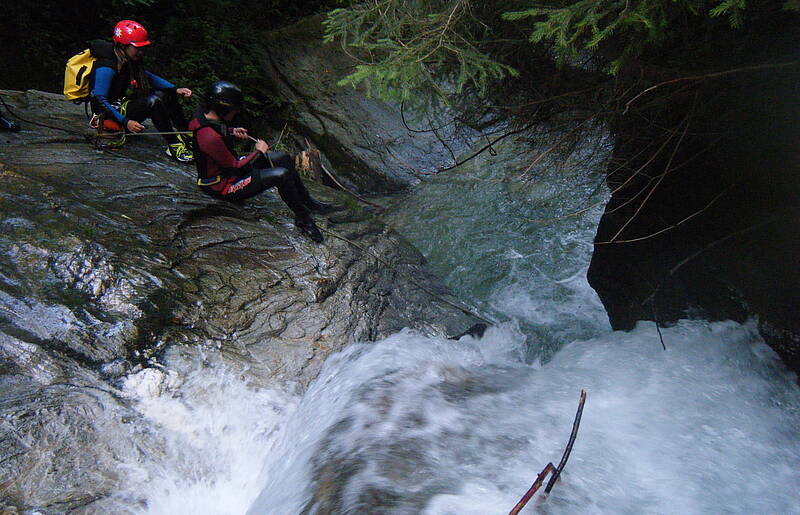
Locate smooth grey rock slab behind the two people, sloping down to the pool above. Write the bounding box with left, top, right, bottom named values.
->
left=262, top=16, right=476, bottom=193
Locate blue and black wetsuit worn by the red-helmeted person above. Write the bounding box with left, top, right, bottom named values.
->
left=89, top=40, right=187, bottom=143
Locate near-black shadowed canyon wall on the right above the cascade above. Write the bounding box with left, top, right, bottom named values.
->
left=589, top=48, right=800, bottom=370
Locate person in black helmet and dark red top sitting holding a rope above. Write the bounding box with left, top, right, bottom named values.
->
left=189, top=81, right=333, bottom=243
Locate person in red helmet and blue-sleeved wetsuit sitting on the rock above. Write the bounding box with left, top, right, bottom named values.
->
left=89, top=20, right=193, bottom=162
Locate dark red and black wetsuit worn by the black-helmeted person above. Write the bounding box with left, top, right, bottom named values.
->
left=189, top=111, right=313, bottom=217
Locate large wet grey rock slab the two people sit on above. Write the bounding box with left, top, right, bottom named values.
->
left=0, top=91, right=475, bottom=513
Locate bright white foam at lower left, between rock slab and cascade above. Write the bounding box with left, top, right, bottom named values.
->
left=117, top=366, right=298, bottom=515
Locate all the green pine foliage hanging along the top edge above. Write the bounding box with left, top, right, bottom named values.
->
left=325, top=0, right=800, bottom=103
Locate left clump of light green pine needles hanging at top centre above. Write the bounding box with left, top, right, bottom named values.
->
left=325, top=0, right=517, bottom=108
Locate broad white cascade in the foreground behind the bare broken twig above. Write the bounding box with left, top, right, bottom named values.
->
left=250, top=323, right=800, bottom=515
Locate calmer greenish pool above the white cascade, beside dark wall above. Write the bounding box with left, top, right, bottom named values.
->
left=385, top=130, right=608, bottom=359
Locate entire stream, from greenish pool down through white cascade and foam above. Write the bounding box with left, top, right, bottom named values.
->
left=119, top=135, right=800, bottom=515
